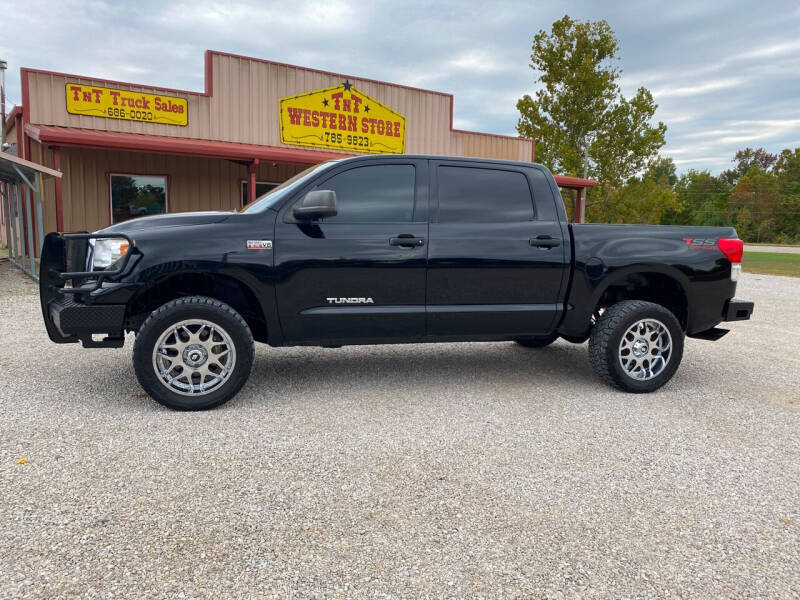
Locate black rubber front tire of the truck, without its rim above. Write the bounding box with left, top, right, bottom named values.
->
left=133, top=296, right=255, bottom=410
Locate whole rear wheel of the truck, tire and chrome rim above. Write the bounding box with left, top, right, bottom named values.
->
left=589, top=300, right=684, bottom=393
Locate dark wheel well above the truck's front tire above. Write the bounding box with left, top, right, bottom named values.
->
left=125, top=273, right=267, bottom=342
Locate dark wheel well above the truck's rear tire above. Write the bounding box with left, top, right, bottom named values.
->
left=594, top=273, right=689, bottom=330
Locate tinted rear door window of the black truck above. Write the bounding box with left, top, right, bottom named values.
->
left=438, top=167, right=533, bottom=223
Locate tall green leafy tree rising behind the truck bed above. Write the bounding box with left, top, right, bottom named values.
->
left=517, top=16, right=667, bottom=185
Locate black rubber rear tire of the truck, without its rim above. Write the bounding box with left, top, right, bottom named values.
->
left=589, top=300, right=684, bottom=393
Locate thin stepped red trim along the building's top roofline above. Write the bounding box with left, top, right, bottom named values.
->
left=20, top=50, right=534, bottom=155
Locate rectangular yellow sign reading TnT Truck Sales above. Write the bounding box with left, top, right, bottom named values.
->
left=66, top=83, right=189, bottom=125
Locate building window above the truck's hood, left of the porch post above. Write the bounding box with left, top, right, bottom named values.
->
left=111, top=173, right=167, bottom=223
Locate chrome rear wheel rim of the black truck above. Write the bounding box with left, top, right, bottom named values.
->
left=619, top=319, right=672, bottom=381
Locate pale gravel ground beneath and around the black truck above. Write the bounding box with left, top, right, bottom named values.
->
left=0, top=264, right=800, bottom=598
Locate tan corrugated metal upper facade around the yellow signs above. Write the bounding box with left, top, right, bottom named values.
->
left=26, top=53, right=531, bottom=160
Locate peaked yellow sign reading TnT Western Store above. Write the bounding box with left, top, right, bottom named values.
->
left=280, top=81, right=406, bottom=154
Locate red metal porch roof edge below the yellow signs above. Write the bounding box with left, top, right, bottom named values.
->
left=25, top=125, right=352, bottom=165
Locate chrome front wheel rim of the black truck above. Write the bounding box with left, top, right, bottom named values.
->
left=153, top=319, right=236, bottom=396
